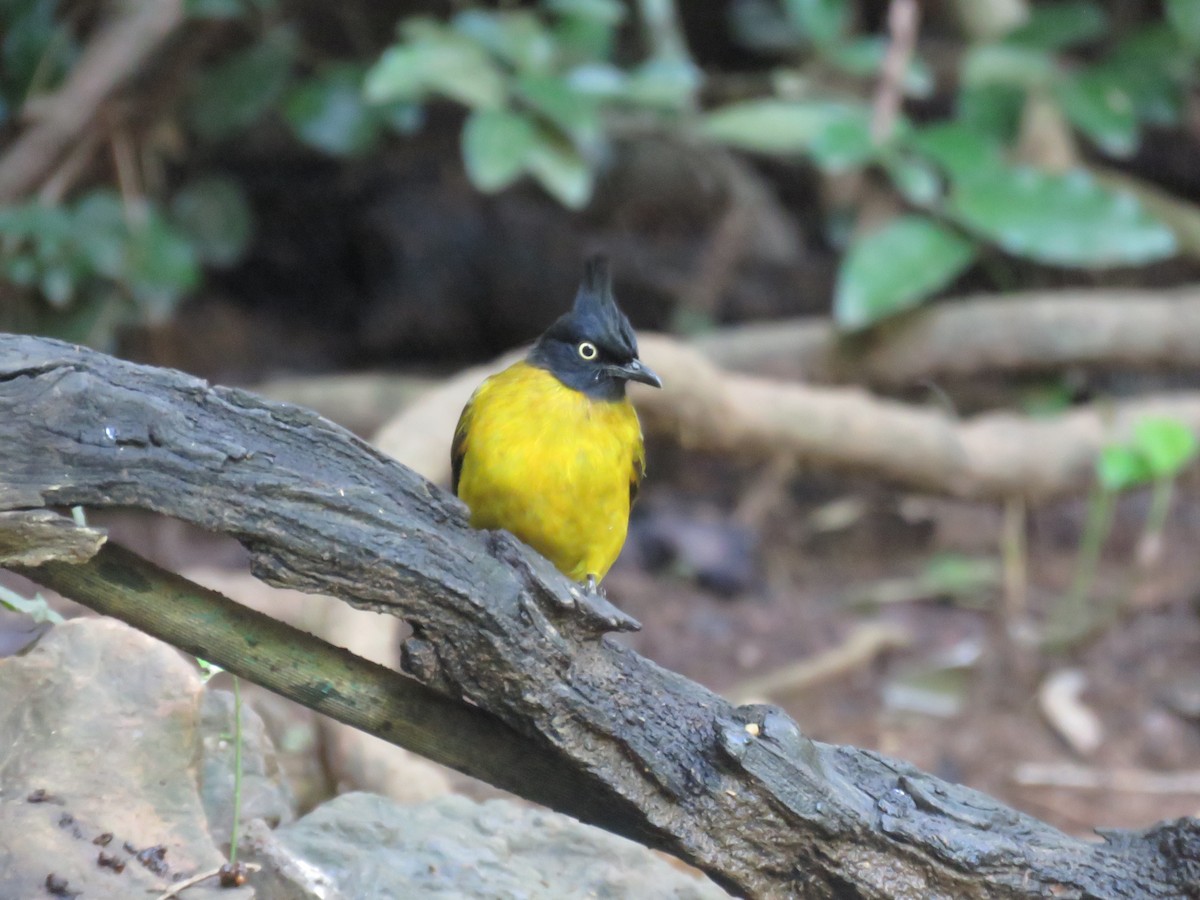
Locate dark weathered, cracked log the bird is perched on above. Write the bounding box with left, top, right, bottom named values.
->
left=0, top=336, right=1200, bottom=900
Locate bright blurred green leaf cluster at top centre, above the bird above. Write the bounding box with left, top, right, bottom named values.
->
left=365, top=0, right=696, bottom=209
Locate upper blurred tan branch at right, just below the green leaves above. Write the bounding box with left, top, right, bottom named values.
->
left=696, top=287, right=1200, bottom=388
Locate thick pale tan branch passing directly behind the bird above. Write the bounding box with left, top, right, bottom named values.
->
left=376, top=331, right=1200, bottom=503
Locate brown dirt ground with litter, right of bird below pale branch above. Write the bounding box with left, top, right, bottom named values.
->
left=608, top=455, right=1200, bottom=834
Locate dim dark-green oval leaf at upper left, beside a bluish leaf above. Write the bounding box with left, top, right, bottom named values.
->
left=188, top=26, right=298, bottom=140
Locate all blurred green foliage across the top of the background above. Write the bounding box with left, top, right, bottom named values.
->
left=0, top=0, right=1200, bottom=342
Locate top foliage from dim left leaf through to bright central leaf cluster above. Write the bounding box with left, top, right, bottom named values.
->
left=180, top=0, right=697, bottom=209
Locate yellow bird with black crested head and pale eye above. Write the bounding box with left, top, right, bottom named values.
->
left=450, top=256, right=662, bottom=593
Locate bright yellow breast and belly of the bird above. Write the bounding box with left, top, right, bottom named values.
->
left=454, top=362, right=644, bottom=581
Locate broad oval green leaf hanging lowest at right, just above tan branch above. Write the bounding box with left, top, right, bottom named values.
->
left=833, top=216, right=976, bottom=330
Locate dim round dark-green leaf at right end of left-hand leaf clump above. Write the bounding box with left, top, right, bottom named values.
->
left=170, top=175, right=254, bottom=269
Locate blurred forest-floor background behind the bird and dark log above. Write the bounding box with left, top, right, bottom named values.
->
left=0, top=0, right=1200, bottom=833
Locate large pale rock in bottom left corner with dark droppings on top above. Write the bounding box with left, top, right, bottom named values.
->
left=0, top=619, right=286, bottom=900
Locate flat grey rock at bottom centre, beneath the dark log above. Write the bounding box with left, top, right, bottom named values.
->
left=246, top=793, right=727, bottom=900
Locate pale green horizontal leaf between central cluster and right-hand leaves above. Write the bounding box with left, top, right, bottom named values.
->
left=701, top=100, right=875, bottom=168
